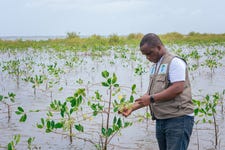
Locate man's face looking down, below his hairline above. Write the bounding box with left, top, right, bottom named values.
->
left=141, top=43, right=161, bottom=63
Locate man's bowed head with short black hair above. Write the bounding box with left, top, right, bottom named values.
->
left=140, top=33, right=166, bottom=63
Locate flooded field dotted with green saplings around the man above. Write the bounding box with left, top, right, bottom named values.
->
left=0, top=45, right=225, bottom=150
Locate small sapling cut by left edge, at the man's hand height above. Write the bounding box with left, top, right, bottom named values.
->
left=0, top=93, right=16, bottom=122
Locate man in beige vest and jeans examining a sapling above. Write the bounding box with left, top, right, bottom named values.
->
left=121, top=33, right=194, bottom=150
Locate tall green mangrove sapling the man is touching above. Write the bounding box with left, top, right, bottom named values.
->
left=89, top=71, right=131, bottom=150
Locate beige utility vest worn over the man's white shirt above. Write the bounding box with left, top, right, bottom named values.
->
left=148, top=53, right=194, bottom=119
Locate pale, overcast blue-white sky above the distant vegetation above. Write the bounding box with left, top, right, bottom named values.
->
left=0, top=0, right=225, bottom=36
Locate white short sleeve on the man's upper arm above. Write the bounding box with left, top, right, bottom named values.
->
left=169, top=57, right=186, bottom=83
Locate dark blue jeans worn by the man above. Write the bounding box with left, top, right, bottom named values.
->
left=156, top=115, right=194, bottom=150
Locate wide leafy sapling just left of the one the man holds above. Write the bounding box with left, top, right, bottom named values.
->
left=37, top=89, right=86, bottom=144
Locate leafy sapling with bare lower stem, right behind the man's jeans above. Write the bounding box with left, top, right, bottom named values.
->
left=193, top=92, right=220, bottom=149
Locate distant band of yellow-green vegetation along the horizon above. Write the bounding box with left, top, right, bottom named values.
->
left=0, top=32, right=225, bottom=51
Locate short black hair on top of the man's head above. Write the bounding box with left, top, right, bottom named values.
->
left=140, top=33, right=163, bottom=47
